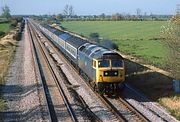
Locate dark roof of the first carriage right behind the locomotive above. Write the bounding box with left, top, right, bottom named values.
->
left=66, top=35, right=88, bottom=49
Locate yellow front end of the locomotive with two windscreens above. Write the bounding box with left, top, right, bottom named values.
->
left=93, top=57, right=125, bottom=93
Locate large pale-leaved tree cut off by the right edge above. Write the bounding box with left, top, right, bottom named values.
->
left=161, top=13, right=180, bottom=80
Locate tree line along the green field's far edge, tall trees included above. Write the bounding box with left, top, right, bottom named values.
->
left=60, top=5, right=172, bottom=21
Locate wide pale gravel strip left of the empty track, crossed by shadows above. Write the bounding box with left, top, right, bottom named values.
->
left=3, top=23, right=42, bottom=121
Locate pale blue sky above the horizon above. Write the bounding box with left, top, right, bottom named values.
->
left=0, top=0, right=180, bottom=15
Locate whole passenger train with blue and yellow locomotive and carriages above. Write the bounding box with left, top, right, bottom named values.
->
left=31, top=20, right=125, bottom=94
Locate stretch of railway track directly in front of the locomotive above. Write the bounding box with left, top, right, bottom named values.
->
left=88, top=84, right=149, bottom=122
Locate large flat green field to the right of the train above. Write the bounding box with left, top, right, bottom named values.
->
left=62, top=21, right=168, bottom=67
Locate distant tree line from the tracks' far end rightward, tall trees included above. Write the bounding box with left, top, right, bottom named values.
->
left=34, top=4, right=172, bottom=24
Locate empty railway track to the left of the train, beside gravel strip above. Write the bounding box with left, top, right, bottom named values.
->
left=28, top=21, right=77, bottom=122
